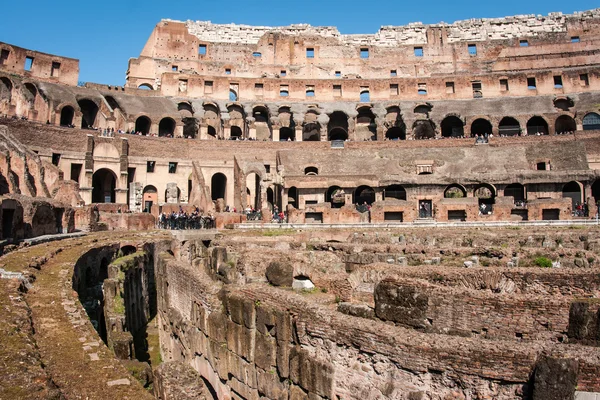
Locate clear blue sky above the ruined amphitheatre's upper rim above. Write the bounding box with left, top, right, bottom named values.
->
left=0, top=0, right=600, bottom=85
